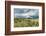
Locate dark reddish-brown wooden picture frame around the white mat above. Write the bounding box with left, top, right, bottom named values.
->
left=5, top=1, right=45, bottom=35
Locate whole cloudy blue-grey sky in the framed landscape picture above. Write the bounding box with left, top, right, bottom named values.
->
left=14, top=8, right=39, bottom=17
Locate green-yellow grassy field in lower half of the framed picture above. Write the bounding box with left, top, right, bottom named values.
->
left=14, top=18, right=39, bottom=27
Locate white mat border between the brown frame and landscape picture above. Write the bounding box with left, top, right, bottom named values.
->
left=11, top=5, right=42, bottom=31
